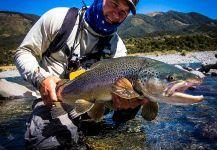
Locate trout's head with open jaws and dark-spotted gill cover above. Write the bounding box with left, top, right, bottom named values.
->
left=134, top=59, right=203, bottom=105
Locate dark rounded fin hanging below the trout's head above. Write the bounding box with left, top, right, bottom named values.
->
left=141, top=101, right=159, bottom=121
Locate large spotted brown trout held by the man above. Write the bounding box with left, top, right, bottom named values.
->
left=54, top=56, right=203, bottom=120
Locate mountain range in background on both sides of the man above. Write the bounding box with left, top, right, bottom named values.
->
left=0, top=11, right=217, bottom=50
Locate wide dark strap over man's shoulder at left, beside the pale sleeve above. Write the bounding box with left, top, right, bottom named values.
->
left=42, top=7, right=79, bottom=57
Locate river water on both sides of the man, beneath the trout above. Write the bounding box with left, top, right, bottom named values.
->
left=0, top=65, right=217, bottom=150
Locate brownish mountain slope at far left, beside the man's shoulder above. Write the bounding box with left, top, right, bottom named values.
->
left=0, top=11, right=39, bottom=50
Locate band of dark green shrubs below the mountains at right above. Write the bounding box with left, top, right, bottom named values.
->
left=124, top=34, right=217, bottom=55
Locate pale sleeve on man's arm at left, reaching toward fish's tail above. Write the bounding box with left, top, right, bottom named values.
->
left=14, top=8, right=67, bottom=89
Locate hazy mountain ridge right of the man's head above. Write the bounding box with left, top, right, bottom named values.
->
left=118, top=11, right=217, bottom=38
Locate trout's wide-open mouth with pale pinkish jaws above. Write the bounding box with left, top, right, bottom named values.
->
left=163, top=79, right=204, bottom=105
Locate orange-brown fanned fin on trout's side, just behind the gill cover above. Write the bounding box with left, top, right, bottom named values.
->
left=112, top=78, right=139, bottom=99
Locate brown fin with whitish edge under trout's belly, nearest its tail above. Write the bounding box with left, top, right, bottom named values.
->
left=69, top=99, right=94, bottom=119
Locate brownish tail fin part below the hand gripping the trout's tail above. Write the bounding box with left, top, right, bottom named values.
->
left=51, top=102, right=67, bottom=119
